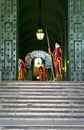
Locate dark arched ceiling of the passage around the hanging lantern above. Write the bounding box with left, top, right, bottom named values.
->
left=19, top=0, right=68, bottom=58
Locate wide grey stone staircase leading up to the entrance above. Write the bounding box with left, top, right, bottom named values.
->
left=0, top=81, right=84, bottom=130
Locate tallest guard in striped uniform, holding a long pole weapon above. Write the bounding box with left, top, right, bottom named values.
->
left=48, top=42, right=63, bottom=80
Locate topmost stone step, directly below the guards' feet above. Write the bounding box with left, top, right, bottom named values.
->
left=0, top=81, right=84, bottom=88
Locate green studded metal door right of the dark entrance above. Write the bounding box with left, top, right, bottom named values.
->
left=68, top=0, right=84, bottom=81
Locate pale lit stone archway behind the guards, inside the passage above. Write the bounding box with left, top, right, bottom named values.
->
left=25, top=50, right=53, bottom=80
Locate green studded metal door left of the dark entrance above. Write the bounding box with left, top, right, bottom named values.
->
left=0, top=0, right=18, bottom=80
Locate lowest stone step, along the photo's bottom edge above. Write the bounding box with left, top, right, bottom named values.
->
left=2, top=125, right=84, bottom=130
